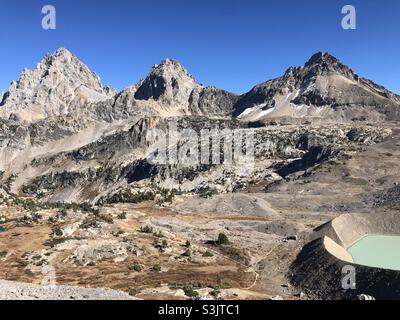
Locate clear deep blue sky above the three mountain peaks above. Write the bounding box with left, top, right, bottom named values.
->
left=0, top=0, right=400, bottom=93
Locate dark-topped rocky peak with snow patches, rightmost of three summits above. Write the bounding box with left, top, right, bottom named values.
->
left=234, top=52, right=400, bottom=121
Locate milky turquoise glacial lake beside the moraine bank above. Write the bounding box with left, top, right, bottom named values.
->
left=347, top=235, right=400, bottom=270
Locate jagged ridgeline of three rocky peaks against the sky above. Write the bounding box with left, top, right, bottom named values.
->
left=0, top=48, right=400, bottom=122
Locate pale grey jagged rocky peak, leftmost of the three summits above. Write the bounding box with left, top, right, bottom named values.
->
left=0, top=48, right=114, bottom=121
